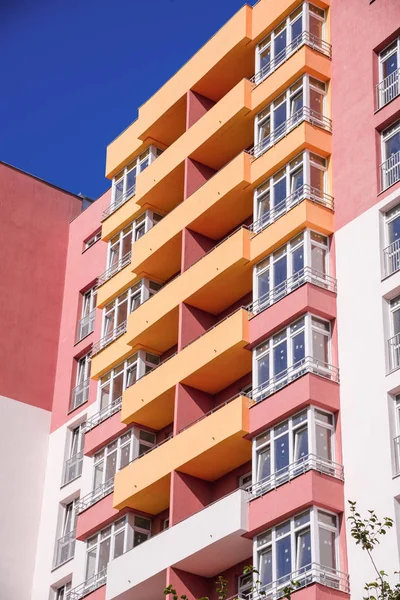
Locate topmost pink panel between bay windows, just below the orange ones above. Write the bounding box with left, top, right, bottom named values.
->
left=249, top=283, right=336, bottom=348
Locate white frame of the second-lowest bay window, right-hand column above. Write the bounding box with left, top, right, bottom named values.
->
left=252, top=405, right=336, bottom=495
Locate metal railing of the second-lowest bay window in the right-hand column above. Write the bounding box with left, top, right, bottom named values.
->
left=244, top=454, right=344, bottom=501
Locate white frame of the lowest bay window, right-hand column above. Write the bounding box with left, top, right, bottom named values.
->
left=253, top=506, right=340, bottom=592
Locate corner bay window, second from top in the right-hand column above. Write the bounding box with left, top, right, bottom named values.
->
left=254, top=75, right=330, bottom=156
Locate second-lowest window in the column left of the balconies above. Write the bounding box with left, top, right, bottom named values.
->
left=93, top=429, right=156, bottom=490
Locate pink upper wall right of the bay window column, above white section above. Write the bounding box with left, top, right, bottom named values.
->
left=331, top=0, right=400, bottom=229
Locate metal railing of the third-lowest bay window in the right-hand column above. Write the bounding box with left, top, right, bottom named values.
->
left=248, top=356, right=339, bottom=403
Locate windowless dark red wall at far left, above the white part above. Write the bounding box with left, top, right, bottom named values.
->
left=0, top=163, right=81, bottom=410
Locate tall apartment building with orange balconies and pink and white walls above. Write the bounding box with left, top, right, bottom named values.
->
left=0, top=0, right=400, bottom=600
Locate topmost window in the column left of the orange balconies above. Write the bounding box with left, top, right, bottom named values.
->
left=111, top=146, right=162, bottom=210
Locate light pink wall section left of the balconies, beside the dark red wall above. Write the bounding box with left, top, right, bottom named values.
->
left=51, top=191, right=110, bottom=431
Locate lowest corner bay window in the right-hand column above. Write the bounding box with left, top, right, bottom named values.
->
left=256, top=507, right=340, bottom=593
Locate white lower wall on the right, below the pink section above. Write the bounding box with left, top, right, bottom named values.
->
left=335, top=186, right=400, bottom=598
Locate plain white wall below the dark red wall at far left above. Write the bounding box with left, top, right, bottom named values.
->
left=0, top=396, right=51, bottom=600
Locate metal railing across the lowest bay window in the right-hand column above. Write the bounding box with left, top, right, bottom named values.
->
left=247, top=562, right=350, bottom=600
